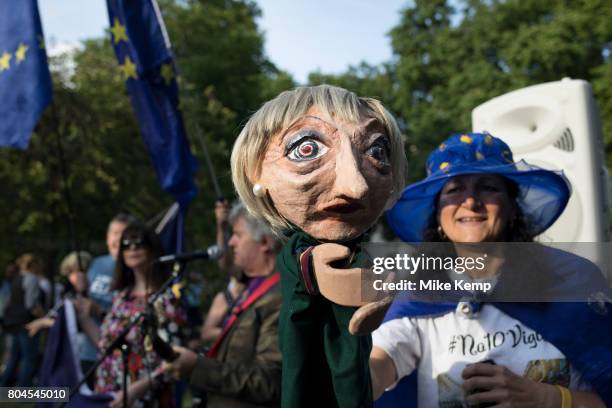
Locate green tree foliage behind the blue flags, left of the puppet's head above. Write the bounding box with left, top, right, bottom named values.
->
left=0, top=1, right=294, bottom=278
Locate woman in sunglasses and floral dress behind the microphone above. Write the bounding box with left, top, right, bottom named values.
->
left=78, top=223, right=186, bottom=407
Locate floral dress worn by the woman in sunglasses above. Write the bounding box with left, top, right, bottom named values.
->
left=95, top=289, right=187, bottom=406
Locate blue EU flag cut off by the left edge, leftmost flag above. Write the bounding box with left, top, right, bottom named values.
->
left=0, top=0, right=51, bottom=149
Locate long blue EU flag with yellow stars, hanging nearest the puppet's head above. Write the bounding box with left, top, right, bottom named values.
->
left=107, top=0, right=197, bottom=206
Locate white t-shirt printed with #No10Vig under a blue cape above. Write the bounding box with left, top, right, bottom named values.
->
left=372, top=303, right=590, bottom=408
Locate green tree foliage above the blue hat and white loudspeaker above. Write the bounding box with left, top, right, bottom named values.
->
left=310, top=0, right=612, bottom=180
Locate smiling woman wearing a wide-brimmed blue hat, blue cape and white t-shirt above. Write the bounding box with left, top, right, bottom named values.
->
left=370, top=133, right=612, bottom=407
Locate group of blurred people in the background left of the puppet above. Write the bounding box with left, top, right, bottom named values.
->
left=0, top=201, right=281, bottom=407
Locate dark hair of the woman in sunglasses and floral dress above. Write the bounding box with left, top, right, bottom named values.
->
left=112, top=222, right=171, bottom=290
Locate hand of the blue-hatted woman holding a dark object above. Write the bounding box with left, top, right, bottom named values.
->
left=462, top=363, right=561, bottom=408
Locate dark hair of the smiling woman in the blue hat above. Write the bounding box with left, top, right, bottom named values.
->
left=423, top=177, right=536, bottom=242
